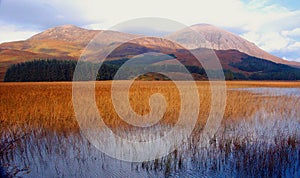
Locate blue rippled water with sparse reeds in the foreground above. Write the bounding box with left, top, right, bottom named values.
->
left=0, top=88, right=300, bottom=177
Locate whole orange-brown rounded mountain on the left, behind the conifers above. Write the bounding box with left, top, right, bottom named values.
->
left=0, top=25, right=138, bottom=81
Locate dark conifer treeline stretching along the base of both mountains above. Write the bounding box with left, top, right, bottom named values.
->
left=4, top=57, right=300, bottom=82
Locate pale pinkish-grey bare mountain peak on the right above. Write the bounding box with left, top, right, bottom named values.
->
left=169, top=24, right=299, bottom=66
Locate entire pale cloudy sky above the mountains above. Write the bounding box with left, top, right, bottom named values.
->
left=0, top=0, right=300, bottom=62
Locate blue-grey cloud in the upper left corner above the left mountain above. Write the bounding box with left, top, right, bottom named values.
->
left=0, top=0, right=92, bottom=29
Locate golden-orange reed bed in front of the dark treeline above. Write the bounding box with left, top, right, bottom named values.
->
left=0, top=81, right=300, bottom=132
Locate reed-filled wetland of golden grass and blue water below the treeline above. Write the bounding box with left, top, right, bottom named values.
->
left=0, top=81, right=300, bottom=177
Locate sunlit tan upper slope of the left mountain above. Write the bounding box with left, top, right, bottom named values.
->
left=0, top=25, right=101, bottom=58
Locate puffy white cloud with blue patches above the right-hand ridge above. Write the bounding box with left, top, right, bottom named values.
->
left=241, top=0, right=300, bottom=60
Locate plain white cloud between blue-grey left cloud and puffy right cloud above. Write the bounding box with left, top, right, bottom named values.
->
left=47, top=0, right=250, bottom=28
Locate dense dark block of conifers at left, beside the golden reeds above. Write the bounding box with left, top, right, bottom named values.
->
left=4, top=59, right=118, bottom=82
